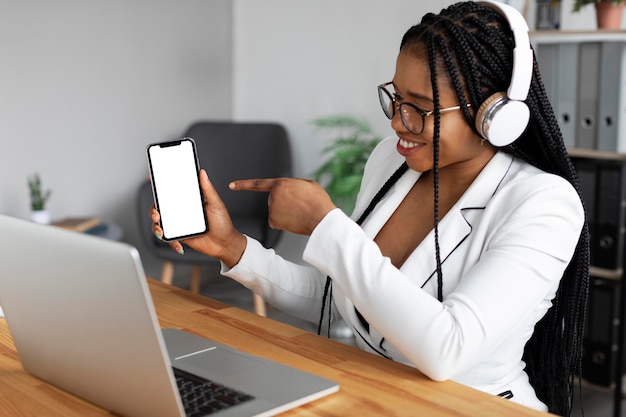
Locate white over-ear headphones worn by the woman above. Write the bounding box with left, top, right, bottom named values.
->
left=476, top=0, right=533, bottom=147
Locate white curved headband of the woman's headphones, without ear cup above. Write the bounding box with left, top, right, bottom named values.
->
left=480, top=0, right=533, bottom=101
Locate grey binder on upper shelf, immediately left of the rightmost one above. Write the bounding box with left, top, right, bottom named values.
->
left=576, top=42, right=601, bottom=149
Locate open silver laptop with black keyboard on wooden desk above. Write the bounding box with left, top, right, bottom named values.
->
left=0, top=215, right=339, bottom=417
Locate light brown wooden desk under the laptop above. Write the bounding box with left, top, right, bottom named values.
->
left=0, top=279, right=548, bottom=417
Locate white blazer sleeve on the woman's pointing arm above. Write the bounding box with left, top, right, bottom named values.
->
left=304, top=174, right=584, bottom=380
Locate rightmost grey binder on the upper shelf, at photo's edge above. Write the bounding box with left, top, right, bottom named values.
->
left=597, top=42, right=626, bottom=152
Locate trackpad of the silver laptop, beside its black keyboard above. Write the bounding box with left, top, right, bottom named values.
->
left=172, top=347, right=264, bottom=376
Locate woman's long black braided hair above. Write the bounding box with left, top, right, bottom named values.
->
left=400, top=2, right=589, bottom=416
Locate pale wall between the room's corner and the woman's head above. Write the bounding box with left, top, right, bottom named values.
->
left=234, top=0, right=453, bottom=176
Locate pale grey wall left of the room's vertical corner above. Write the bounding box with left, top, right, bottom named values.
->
left=0, top=0, right=232, bottom=276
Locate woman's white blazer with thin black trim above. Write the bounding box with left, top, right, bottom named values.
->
left=222, top=137, right=584, bottom=410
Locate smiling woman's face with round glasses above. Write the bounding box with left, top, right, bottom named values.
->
left=391, top=51, right=495, bottom=173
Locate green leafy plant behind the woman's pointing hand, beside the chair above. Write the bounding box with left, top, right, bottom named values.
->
left=313, top=115, right=380, bottom=214
